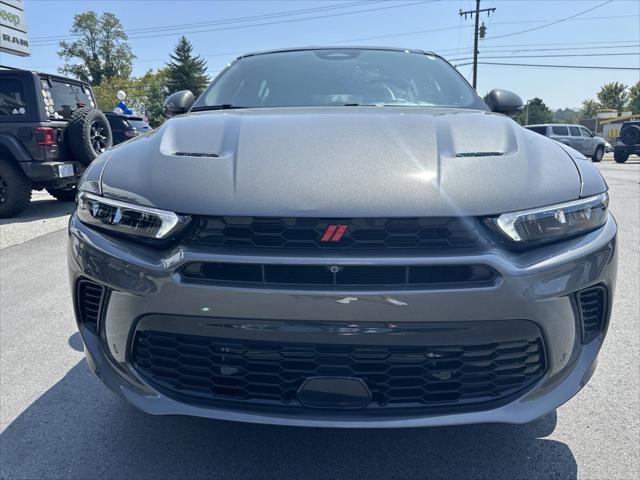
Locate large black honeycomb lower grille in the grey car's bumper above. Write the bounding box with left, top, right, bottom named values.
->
left=132, top=331, right=546, bottom=410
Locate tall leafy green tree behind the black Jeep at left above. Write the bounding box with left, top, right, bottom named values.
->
left=58, top=12, right=135, bottom=85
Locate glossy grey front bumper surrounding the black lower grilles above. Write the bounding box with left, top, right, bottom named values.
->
left=68, top=216, right=617, bottom=427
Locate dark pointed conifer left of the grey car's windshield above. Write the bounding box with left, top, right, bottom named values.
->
left=167, top=36, right=209, bottom=97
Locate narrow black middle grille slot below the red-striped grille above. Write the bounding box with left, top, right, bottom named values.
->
left=181, top=262, right=497, bottom=288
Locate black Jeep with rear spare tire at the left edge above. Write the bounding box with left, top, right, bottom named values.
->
left=0, top=67, right=112, bottom=218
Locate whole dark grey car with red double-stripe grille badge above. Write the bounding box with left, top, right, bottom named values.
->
left=68, top=48, right=617, bottom=427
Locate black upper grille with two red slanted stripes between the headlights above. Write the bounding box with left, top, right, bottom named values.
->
left=187, top=217, right=487, bottom=251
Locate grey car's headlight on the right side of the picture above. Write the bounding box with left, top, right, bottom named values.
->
left=488, top=193, right=609, bottom=245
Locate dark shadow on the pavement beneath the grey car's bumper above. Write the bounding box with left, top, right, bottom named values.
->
left=0, top=360, right=577, bottom=479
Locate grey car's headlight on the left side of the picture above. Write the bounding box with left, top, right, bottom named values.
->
left=77, top=192, right=191, bottom=240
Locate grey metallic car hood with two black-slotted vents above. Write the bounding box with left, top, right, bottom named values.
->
left=101, top=107, right=581, bottom=217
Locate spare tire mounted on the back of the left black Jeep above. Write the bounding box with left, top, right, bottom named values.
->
left=66, top=107, right=113, bottom=165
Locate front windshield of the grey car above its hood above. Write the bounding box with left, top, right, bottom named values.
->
left=193, top=49, right=486, bottom=110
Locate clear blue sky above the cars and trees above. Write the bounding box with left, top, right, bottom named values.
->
left=5, top=0, right=640, bottom=109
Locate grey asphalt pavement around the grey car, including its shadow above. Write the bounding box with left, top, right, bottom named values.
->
left=0, top=161, right=640, bottom=479
